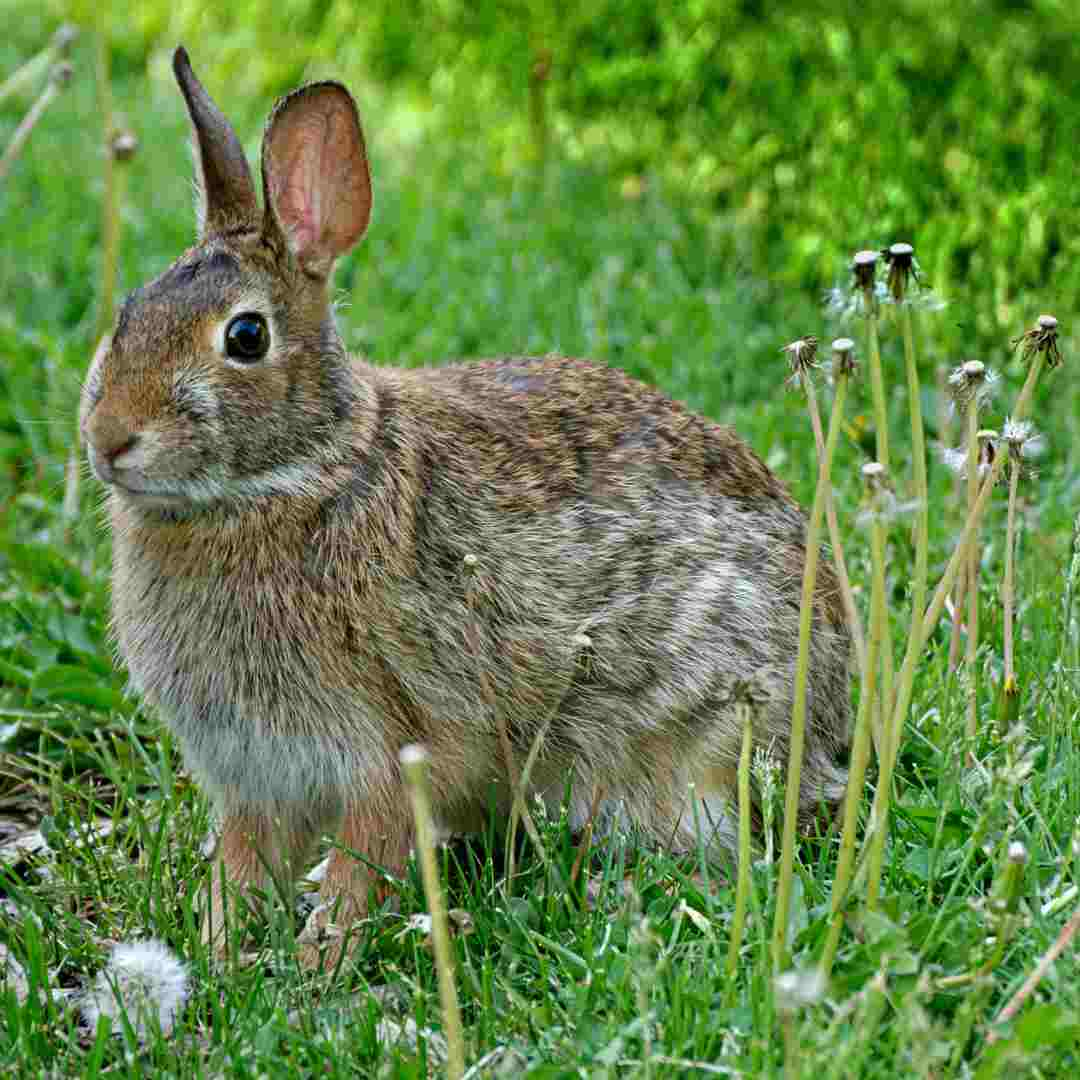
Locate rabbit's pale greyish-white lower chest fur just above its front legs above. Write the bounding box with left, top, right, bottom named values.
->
left=113, top=552, right=384, bottom=813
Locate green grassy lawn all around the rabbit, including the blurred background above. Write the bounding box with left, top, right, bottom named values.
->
left=0, top=0, right=1080, bottom=1078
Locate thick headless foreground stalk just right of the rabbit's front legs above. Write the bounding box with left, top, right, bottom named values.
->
left=400, top=745, right=465, bottom=1080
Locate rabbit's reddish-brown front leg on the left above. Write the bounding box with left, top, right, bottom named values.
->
left=202, top=809, right=318, bottom=956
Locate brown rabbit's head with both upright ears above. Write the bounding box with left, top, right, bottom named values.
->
left=80, top=48, right=372, bottom=515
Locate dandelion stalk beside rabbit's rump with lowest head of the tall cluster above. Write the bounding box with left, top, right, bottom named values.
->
left=821, top=461, right=887, bottom=977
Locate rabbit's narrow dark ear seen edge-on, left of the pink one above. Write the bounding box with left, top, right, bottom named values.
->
left=173, top=45, right=259, bottom=237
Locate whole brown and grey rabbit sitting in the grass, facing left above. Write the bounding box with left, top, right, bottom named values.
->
left=80, top=46, right=850, bottom=964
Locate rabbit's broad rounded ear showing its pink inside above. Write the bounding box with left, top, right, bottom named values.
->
left=262, top=82, right=372, bottom=278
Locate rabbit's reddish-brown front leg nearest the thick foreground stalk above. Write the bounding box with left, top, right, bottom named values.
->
left=298, top=791, right=414, bottom=971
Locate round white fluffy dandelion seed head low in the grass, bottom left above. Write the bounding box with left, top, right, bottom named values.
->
left=81, top=937, right=188, bottom=1042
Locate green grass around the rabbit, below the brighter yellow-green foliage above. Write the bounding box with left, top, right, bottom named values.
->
left=0, top=11, right=1080, bottom=1078
